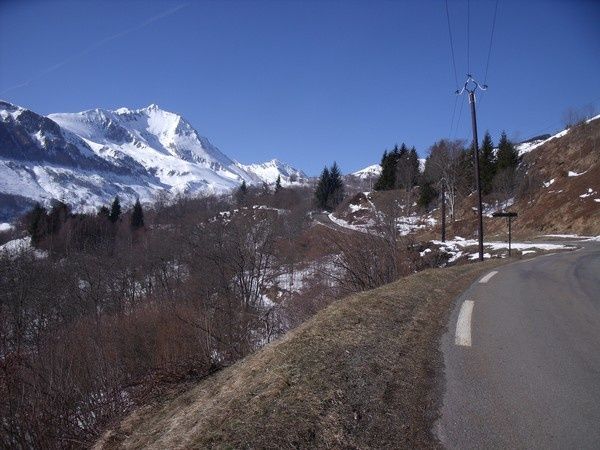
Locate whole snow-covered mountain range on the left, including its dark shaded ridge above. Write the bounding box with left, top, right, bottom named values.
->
left=0, top=101, right=303, bottom=218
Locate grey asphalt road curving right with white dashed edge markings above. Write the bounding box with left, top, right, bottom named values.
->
left=435, top=243, right=600, bottom=449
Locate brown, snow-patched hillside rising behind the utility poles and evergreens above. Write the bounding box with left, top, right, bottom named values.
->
left=330, top=116, right=600, bottom=241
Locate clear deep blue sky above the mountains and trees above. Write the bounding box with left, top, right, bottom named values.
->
left=0, top=0, right=600, bottom=174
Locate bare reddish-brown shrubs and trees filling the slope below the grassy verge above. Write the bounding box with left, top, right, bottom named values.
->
left=0, top=181, right=432, bottom=448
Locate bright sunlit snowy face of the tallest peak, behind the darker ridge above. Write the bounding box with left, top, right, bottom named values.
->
left=48, top=105, right=254, bottom=193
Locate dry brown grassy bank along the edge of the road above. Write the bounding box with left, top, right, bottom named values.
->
left=97, top=261, right=499, bottom=449
